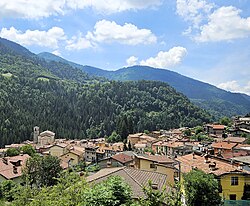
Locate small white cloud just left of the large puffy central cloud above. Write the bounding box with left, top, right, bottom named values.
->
left=65, top=34, right=95, bottom=50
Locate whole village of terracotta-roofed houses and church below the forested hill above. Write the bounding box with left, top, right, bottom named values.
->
left=0, top=117, right=250, bottom=203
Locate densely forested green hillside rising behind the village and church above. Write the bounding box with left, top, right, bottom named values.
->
left=0, top=37, right=211, bottom=147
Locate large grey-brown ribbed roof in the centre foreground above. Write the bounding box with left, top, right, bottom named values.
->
left=87, top=167, right=170, bottom=198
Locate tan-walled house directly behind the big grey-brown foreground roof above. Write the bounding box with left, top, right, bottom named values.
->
left=135, top=154, right=176, bottom=184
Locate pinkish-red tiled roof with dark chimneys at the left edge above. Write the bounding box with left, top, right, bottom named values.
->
left=0, top=154, right=30, bottom=180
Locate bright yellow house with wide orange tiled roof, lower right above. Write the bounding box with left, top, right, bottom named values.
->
left=177, top=153, right=250, bottom=200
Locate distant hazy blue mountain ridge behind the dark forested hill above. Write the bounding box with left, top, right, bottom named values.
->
left=38, top=53, right=250, bottom=118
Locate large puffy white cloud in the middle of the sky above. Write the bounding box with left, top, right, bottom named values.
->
left=86, top=20, right=157, bottom=45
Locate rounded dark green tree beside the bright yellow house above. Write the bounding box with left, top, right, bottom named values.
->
left=184, top=170, right=221, bottom=206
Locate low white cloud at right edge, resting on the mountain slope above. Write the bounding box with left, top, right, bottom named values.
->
left=218, top=80, right=250, bottom=95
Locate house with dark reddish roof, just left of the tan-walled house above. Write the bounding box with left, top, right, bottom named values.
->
left=98, top=153, right=134, bottom=168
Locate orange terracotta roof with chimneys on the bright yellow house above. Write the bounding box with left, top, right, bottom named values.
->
left=176, top=154, right=250, bottom=176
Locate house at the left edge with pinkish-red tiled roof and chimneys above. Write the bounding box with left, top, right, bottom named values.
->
left=0, top=154, right=30, bottom=183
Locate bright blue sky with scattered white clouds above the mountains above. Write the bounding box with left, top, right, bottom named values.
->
left=0, top=0, right=250, bottom=95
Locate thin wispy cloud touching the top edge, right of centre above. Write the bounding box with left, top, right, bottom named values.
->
left=176, top=0, right=214, bottom=27
